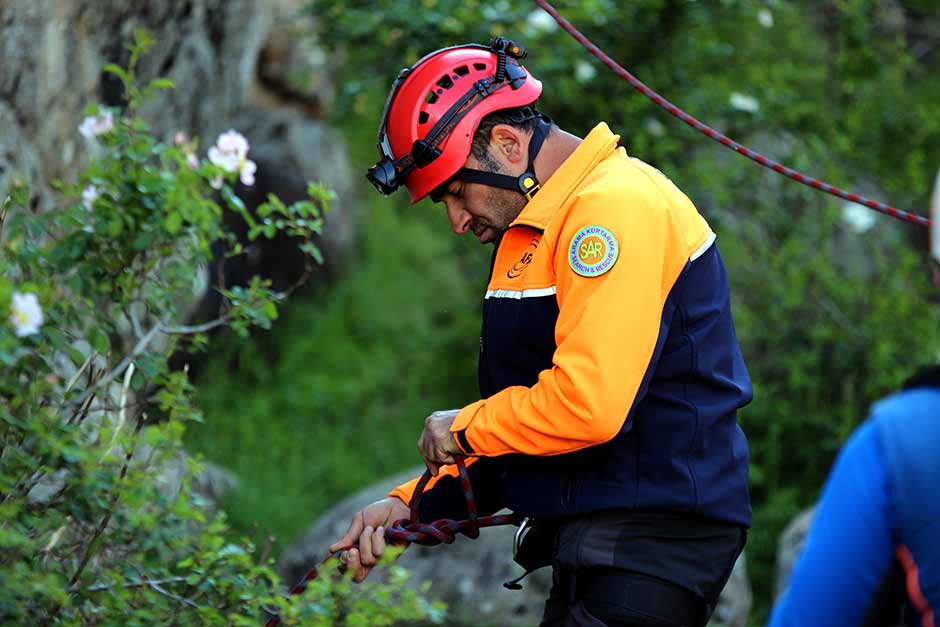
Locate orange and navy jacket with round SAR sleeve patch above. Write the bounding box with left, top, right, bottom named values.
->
left=391, top=123, right=751, bottom=525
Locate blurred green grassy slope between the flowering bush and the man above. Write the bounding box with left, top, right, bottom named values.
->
left=188, top=203, right=482, bottom=547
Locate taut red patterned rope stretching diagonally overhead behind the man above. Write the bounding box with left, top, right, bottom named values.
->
left=535, top=0, right=930, bottom=227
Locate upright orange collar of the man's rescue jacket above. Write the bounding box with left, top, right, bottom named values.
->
left=509, top=122, right=620, bottom=230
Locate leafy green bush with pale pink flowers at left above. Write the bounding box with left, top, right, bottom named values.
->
left=0, top=32, right=440, bottom=626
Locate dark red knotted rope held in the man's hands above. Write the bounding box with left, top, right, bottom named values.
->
left=265, top=455, right=522, bottom=627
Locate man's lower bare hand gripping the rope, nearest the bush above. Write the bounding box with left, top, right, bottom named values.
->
left=330, top=496, right=411, bottom=583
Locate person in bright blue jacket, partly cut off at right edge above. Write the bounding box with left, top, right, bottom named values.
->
left=769, top=178, right=940, bottom=627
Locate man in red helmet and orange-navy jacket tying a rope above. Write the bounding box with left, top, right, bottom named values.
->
left=331, top=38, right=751, bottom=626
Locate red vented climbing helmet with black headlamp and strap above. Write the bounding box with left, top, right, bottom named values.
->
left=366, top=37, right=542, bottom=203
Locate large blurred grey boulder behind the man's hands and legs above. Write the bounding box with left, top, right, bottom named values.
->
left=277, top=468, right=751, bottom=627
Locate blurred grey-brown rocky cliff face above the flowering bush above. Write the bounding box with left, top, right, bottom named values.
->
left=0, top=0, right=353, bottom=258
